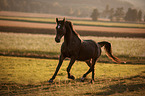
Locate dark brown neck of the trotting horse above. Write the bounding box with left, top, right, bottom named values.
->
left=64, top=25, right=81, bottom=46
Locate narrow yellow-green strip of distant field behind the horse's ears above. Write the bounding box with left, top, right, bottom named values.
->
left=0, top=16, right=145, bottom=28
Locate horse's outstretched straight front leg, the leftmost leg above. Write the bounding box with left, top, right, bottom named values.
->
left=48, top=55, right=65, bottom=83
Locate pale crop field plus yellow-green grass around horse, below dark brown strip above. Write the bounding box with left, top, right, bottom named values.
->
left=0, top=33, right=145, bottom=96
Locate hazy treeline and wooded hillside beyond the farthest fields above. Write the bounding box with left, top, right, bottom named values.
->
left=0, top=0, right=145, bottom=22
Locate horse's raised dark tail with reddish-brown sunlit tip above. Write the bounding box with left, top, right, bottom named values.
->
left=98, top=41, right=122, bottom=63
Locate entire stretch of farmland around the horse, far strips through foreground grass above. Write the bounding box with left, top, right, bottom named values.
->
left=0, top=13, right=145, bottom=96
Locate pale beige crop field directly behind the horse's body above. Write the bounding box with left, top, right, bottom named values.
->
left=0, top=33, right=145, bottom=62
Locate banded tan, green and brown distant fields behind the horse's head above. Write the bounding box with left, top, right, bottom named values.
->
left=0, top=12, right=145, bottom=38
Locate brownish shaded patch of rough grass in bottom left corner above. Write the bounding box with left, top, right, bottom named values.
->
left=0, top=79, right=79, bottom=96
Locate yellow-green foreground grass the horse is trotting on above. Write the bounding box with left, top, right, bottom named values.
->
left=0, top=56, right=145, bottom=96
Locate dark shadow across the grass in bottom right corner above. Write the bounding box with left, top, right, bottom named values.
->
left=83, top=71, right=145, bottom=96
